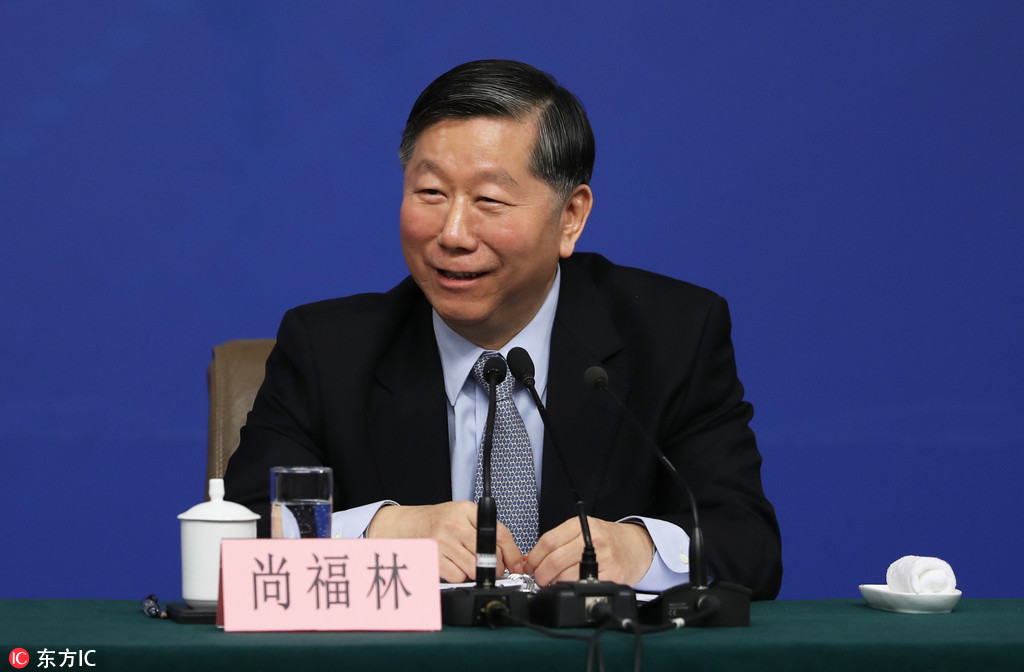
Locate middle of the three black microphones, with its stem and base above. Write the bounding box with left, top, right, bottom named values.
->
left=508, top=347, right=637, bottom=628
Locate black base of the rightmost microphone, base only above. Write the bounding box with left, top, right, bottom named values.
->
left=640, top=581, right=751, bottom=628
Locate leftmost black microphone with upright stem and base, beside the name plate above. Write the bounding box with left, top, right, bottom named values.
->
left=441, top=355, right=528, bottom=627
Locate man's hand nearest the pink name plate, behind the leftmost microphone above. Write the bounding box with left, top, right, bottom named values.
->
left=367, top=502, right=523, bottom=583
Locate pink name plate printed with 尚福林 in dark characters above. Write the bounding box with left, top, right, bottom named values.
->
left=217, top=539, right=441, bottom=632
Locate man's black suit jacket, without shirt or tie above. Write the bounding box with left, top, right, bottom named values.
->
left=225, top=253, right=781, bottom=598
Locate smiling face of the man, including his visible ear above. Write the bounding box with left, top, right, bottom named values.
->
left=400, top=117, right=592, bottom=349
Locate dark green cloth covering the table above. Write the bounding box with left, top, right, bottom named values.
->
left=0, top=599, right=1024, bottom=672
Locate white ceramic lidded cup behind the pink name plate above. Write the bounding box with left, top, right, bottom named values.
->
left=178, top=478, right=259, bottom=611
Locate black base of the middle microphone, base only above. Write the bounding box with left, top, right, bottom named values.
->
left=529, top=580, right=637, bottom=628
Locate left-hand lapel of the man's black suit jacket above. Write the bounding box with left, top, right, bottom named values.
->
left=368, top=290, right=452, bottom=504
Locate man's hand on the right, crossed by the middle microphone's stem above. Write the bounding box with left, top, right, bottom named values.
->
left=526, top=516, right=654, bottom=586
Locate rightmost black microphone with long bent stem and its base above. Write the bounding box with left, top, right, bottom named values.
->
left=583, top=366, right=751, bottom=626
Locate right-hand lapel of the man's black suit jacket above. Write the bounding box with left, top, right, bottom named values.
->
left=540, top=259, right=629, bottom=534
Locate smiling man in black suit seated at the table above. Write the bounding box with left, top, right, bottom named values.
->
left=225, top=61, right=781, bottom=598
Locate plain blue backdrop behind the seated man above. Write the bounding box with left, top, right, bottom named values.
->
left=0, top=0, right=1024, bottom=599
